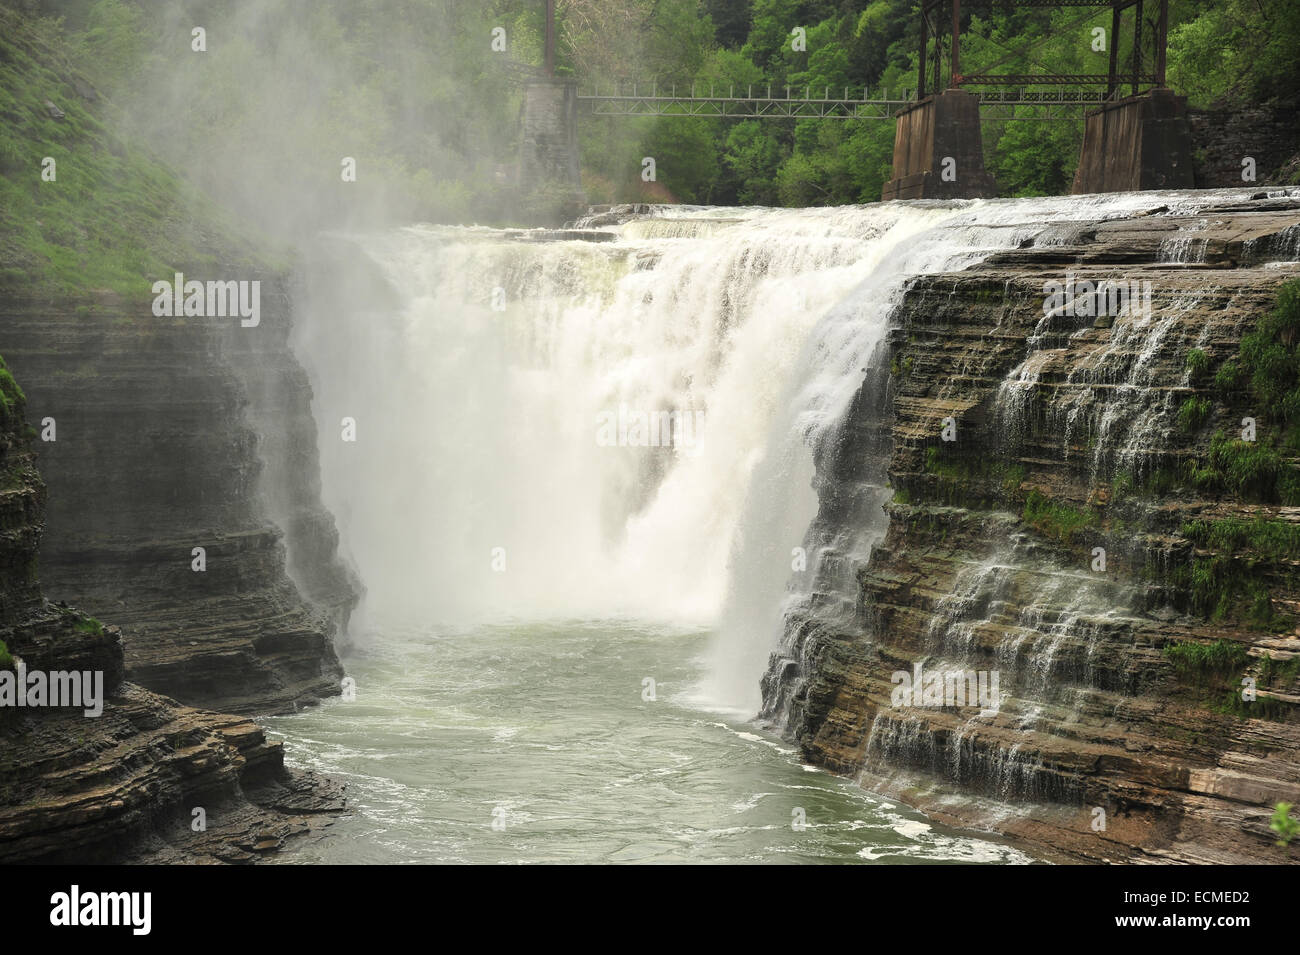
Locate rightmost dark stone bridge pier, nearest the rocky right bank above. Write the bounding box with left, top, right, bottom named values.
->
left=1071, top=88, right=1196, bottom=195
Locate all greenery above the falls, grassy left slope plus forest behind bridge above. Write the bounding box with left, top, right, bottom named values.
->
left=10, top=0, right=1300, bottom=237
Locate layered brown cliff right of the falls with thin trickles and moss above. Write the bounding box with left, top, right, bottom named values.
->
left=764, top=197, right=1300, bottom=861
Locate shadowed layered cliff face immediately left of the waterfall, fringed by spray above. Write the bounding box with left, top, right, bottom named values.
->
left=0, top=285, right=359, bottom=713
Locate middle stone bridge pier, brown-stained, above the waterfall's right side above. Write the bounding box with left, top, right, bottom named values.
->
left=880, top=90, right=997, bottom=201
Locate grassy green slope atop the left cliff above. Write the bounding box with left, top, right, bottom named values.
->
left=0, top=4, right=267, bottom=299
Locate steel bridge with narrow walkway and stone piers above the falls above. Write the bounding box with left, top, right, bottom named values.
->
left=520, top=0, right=1192, bottom=207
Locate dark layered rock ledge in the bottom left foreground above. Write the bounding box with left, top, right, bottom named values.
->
left=0, top=363, right=343, bottom=864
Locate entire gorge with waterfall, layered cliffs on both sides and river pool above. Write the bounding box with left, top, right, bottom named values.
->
left=0, top=26, right=1300, bottom=863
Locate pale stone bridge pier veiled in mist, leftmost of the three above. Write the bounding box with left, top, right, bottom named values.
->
left=519, top=78, right=586, bottom=225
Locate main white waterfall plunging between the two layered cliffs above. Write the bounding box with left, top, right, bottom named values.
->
left=287, top=194, right=1268, bottom=713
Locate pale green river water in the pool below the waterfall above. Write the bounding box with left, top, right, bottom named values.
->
left=269, top=622, right=1031, bottom=864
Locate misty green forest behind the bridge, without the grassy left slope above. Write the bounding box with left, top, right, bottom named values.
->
left=10, top=0, right=1300, bottom=224
